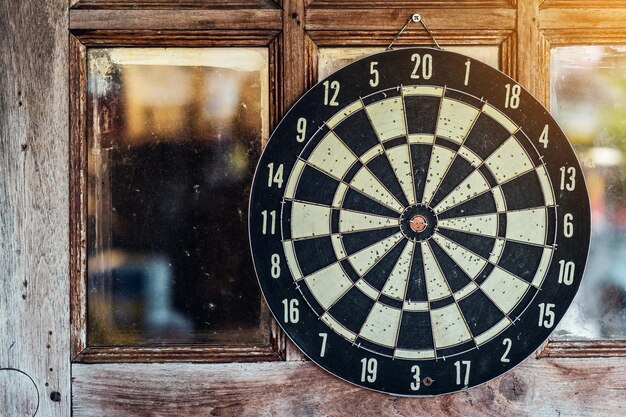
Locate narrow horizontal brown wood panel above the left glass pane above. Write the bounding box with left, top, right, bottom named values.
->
left=70, top=9, right=282, bottom=30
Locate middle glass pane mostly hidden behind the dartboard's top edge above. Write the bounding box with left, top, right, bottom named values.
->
left=317, top=45, right=500, bottom=80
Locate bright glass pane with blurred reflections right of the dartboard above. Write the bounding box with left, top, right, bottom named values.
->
left=550, top=46, right=626, bottom=340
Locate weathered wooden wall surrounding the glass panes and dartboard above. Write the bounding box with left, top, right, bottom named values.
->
left=0, top=0, right=626, bottom=417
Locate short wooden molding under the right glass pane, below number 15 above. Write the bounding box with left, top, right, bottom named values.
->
left=538, top=340, right=626, bottom=358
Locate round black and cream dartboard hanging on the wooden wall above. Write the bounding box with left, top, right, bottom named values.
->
left=249, top=48, right=590, bottom=396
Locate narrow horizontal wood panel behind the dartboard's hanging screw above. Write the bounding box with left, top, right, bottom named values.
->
left=306, top=8, right=523, bottom=30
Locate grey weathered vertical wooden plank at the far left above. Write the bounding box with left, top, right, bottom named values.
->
left=0, top=0, right=70, bottom=417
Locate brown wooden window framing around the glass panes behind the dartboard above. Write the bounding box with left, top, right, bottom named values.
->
left=69, top=0, right=626, bottom=363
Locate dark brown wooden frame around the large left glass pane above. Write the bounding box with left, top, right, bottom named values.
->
left=69, top=6, right=285, bottom=363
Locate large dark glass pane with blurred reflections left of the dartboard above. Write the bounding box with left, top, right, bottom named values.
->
left=87, top=48, right=269, bottom=346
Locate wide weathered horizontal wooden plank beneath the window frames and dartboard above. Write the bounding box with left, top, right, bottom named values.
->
left=72, top=358, right=626, bottom=417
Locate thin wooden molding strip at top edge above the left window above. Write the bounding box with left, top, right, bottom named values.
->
left=70, top=0, right=279, bottom=10
